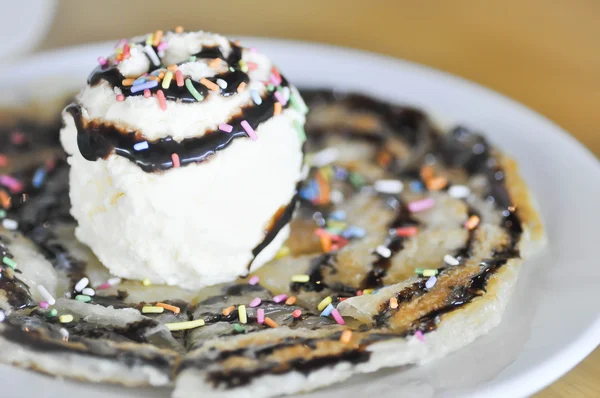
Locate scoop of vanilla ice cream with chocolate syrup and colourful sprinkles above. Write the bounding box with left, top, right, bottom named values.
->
left=61, top=32, right=306, bottom=289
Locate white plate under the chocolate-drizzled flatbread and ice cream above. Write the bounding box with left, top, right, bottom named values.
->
left=0, top=38, right=600, bottom=398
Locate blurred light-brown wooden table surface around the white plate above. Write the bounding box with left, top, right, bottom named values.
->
left=41, top=0, right=600, bottom=398
